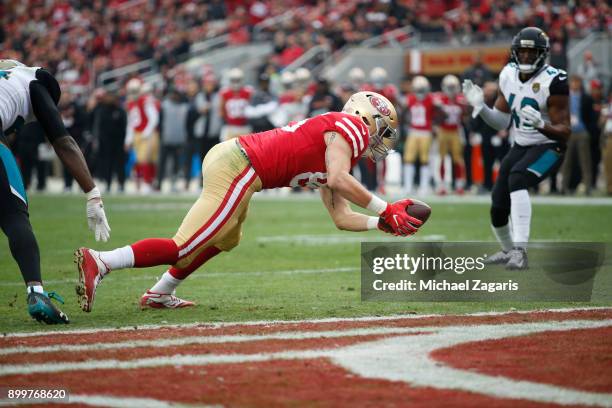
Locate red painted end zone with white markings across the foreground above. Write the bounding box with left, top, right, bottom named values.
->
left=0, top=309, right=612, bottom=407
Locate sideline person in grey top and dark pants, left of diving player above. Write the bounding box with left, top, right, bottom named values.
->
left=157, top=88, right=189, bottom=192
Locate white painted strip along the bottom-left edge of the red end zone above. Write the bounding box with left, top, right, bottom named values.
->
left=0, top=394, right=210, bottom=408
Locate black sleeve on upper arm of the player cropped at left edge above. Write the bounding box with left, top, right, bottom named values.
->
left=30, top=80, right=68, bottom=143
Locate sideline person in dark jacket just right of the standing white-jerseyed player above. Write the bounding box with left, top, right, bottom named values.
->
left=561, top=75, right=597, bottom=195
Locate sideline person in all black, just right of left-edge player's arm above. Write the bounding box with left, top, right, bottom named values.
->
left=89, top=89, right=127, bottom=192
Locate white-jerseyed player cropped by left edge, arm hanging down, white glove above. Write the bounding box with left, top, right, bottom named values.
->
left=0, top=60, right=110, bottom=324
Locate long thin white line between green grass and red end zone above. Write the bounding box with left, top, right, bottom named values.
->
left=0, top=306, right=612, bottom=338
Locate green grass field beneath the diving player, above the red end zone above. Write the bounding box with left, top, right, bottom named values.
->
left=0, top=195, right=612, bottom=332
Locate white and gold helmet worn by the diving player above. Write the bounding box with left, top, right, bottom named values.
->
left=342, top=91, right=398, bottom=161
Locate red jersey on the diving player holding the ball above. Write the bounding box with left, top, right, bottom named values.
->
left=239, top=112, right=369, bottom=188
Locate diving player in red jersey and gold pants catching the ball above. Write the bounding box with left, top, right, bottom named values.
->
left=75, top=92, right=422, bottom=312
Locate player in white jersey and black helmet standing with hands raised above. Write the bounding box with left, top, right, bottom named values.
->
left=463, top=27, right=571, bottom=269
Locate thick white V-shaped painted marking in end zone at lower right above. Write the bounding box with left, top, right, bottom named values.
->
left=331, top=319, right=612, bottom=407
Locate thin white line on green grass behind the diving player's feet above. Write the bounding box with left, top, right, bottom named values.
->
left=0, top=266, right=360, bottom=287
